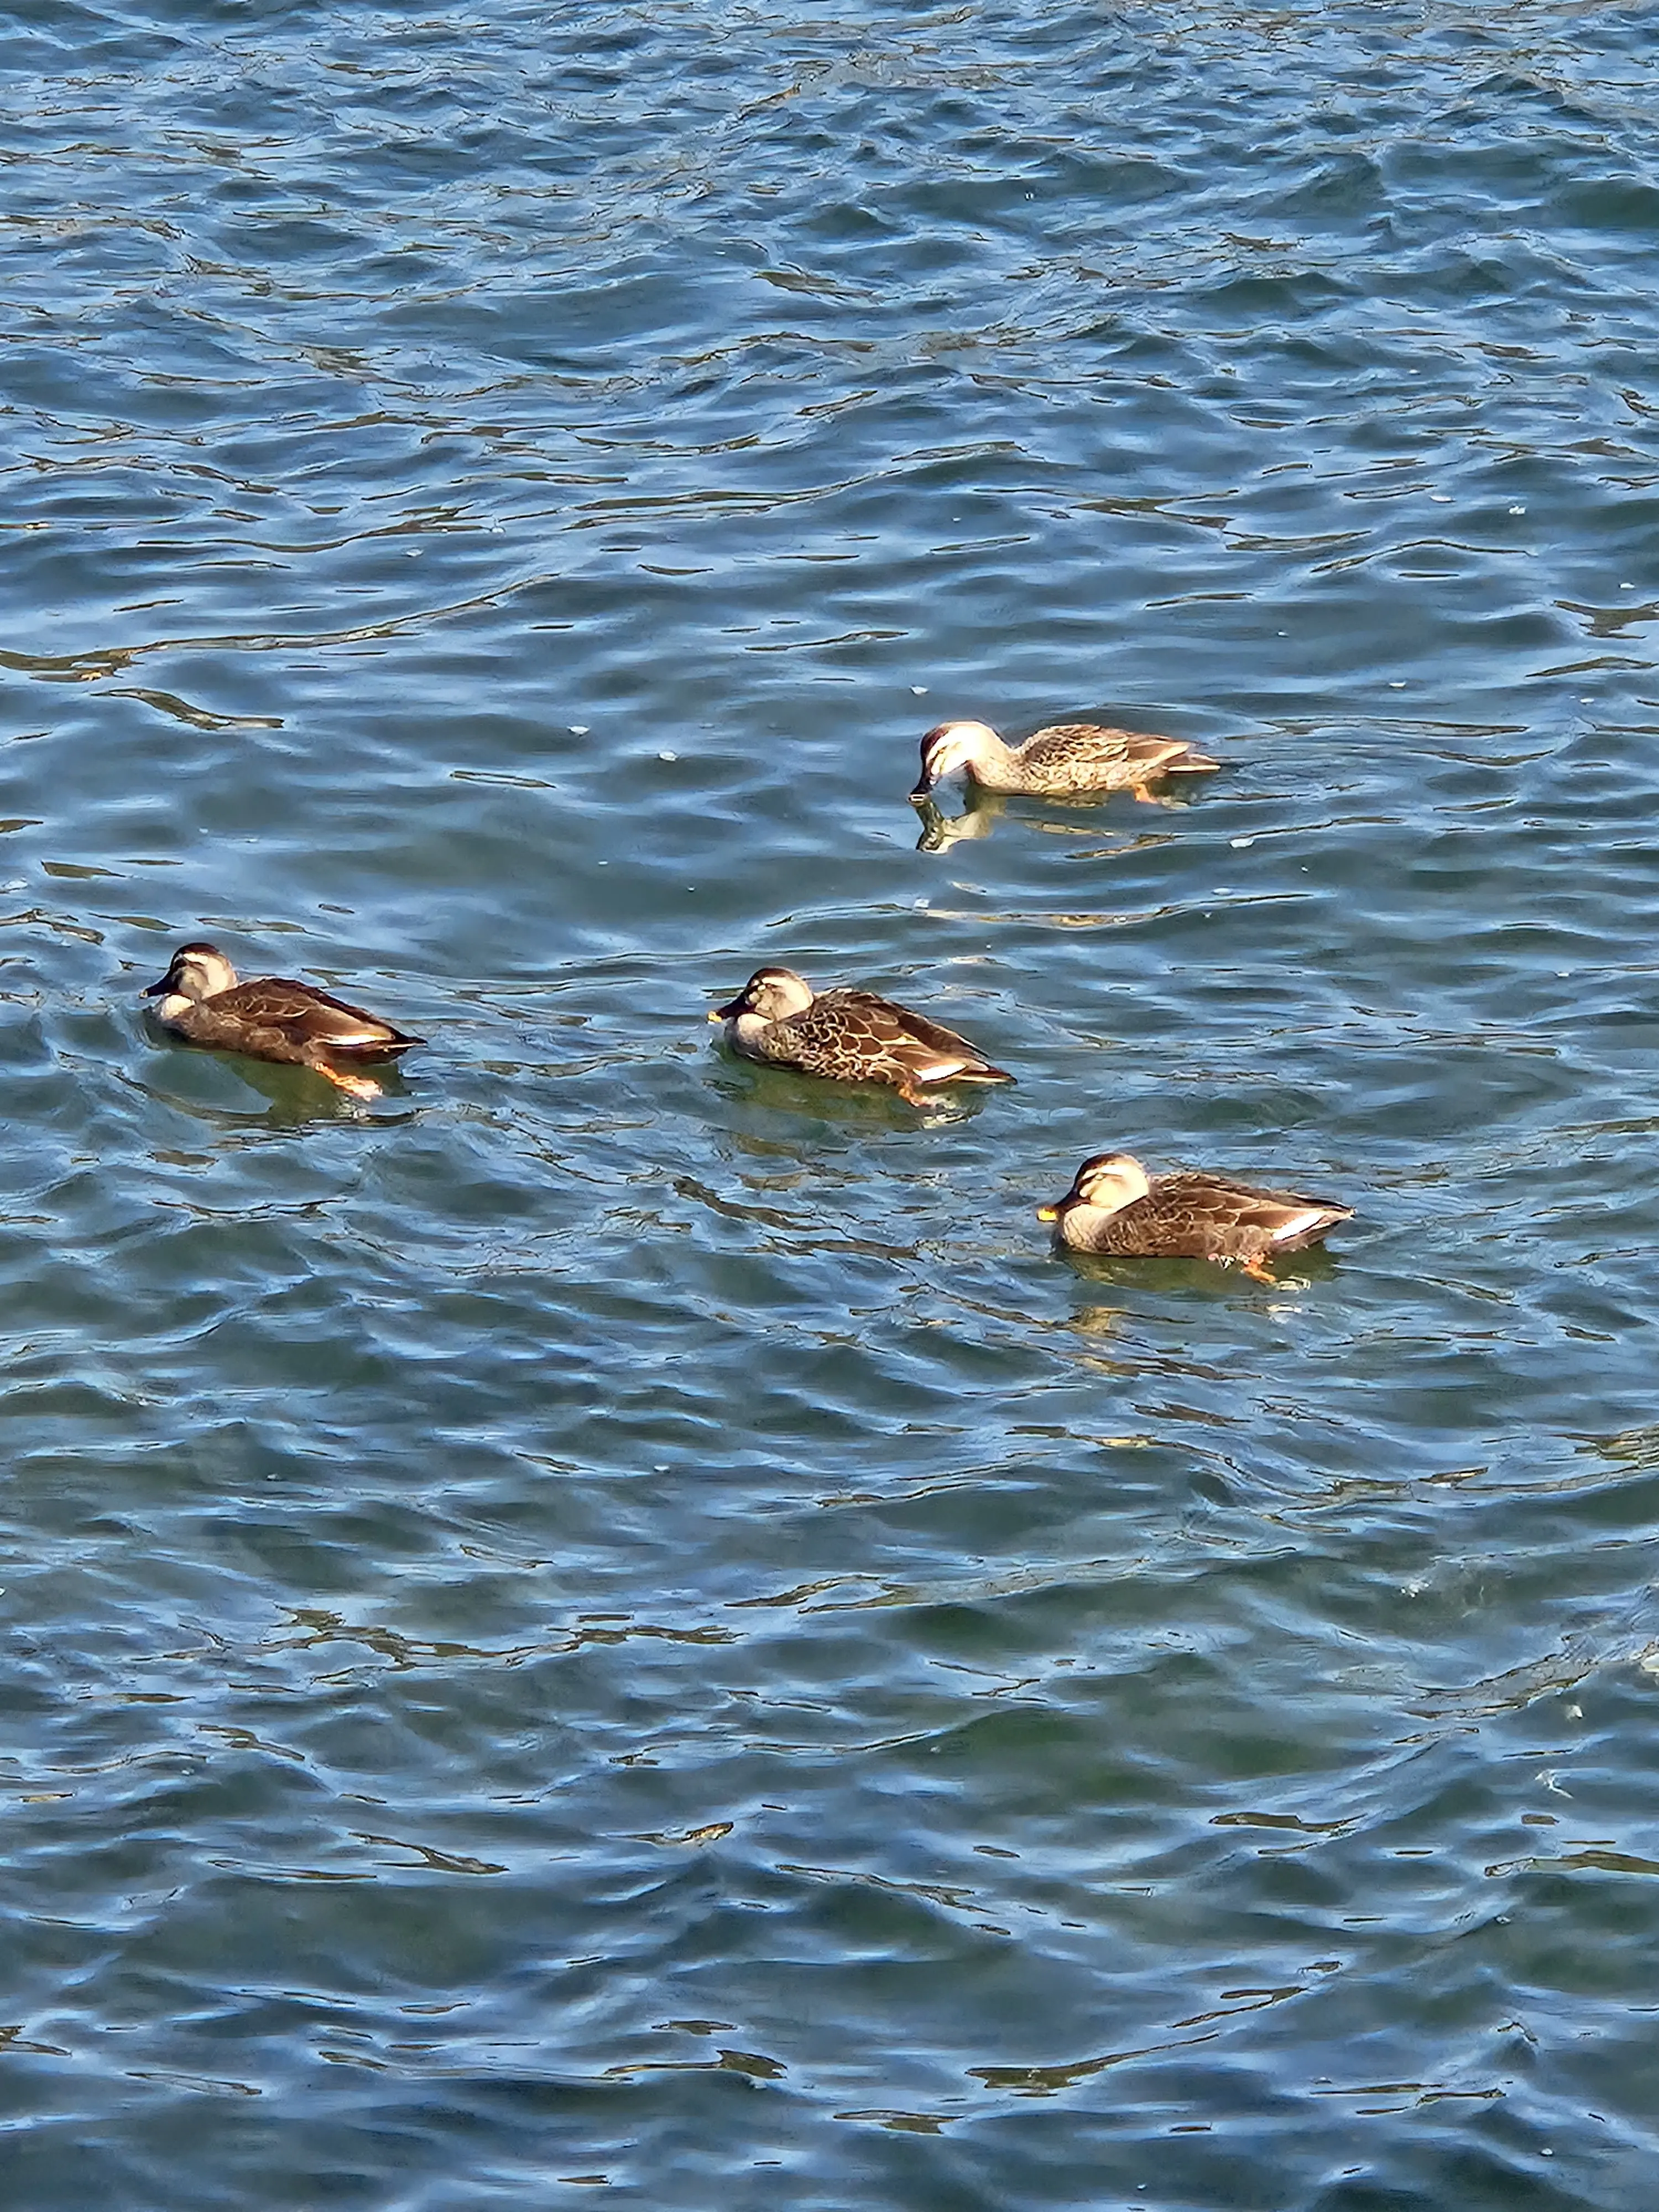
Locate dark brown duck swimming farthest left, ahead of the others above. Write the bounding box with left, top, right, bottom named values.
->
left=144, top=940, right=427, bottom=1099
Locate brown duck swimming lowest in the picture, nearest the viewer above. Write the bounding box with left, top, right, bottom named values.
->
left=1037, top=1152, right=1354, bottom=1283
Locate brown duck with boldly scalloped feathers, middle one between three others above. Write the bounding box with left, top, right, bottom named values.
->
left=708, top=967, right=1013, bottom=1106
